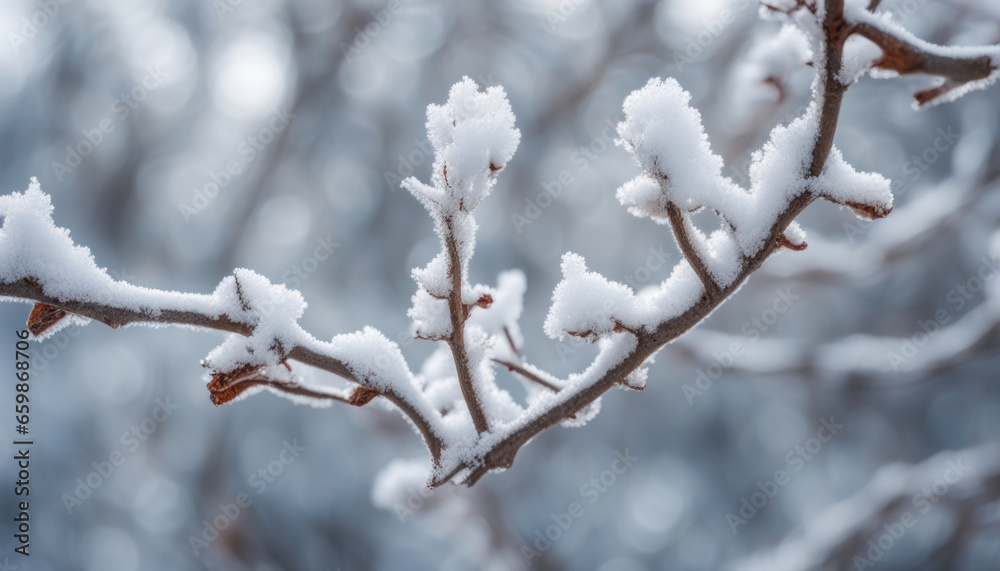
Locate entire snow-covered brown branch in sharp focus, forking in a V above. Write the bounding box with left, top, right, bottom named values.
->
left=0, top=0, right=1000, bottom=492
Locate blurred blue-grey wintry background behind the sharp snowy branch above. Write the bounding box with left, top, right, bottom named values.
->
left=0, top=0, right=1000, bottom=571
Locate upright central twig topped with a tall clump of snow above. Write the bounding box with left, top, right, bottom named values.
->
left=403, top=77, right=521, bottom=434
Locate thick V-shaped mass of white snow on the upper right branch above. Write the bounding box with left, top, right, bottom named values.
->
left=617, top=73, right=892, bottom=287
